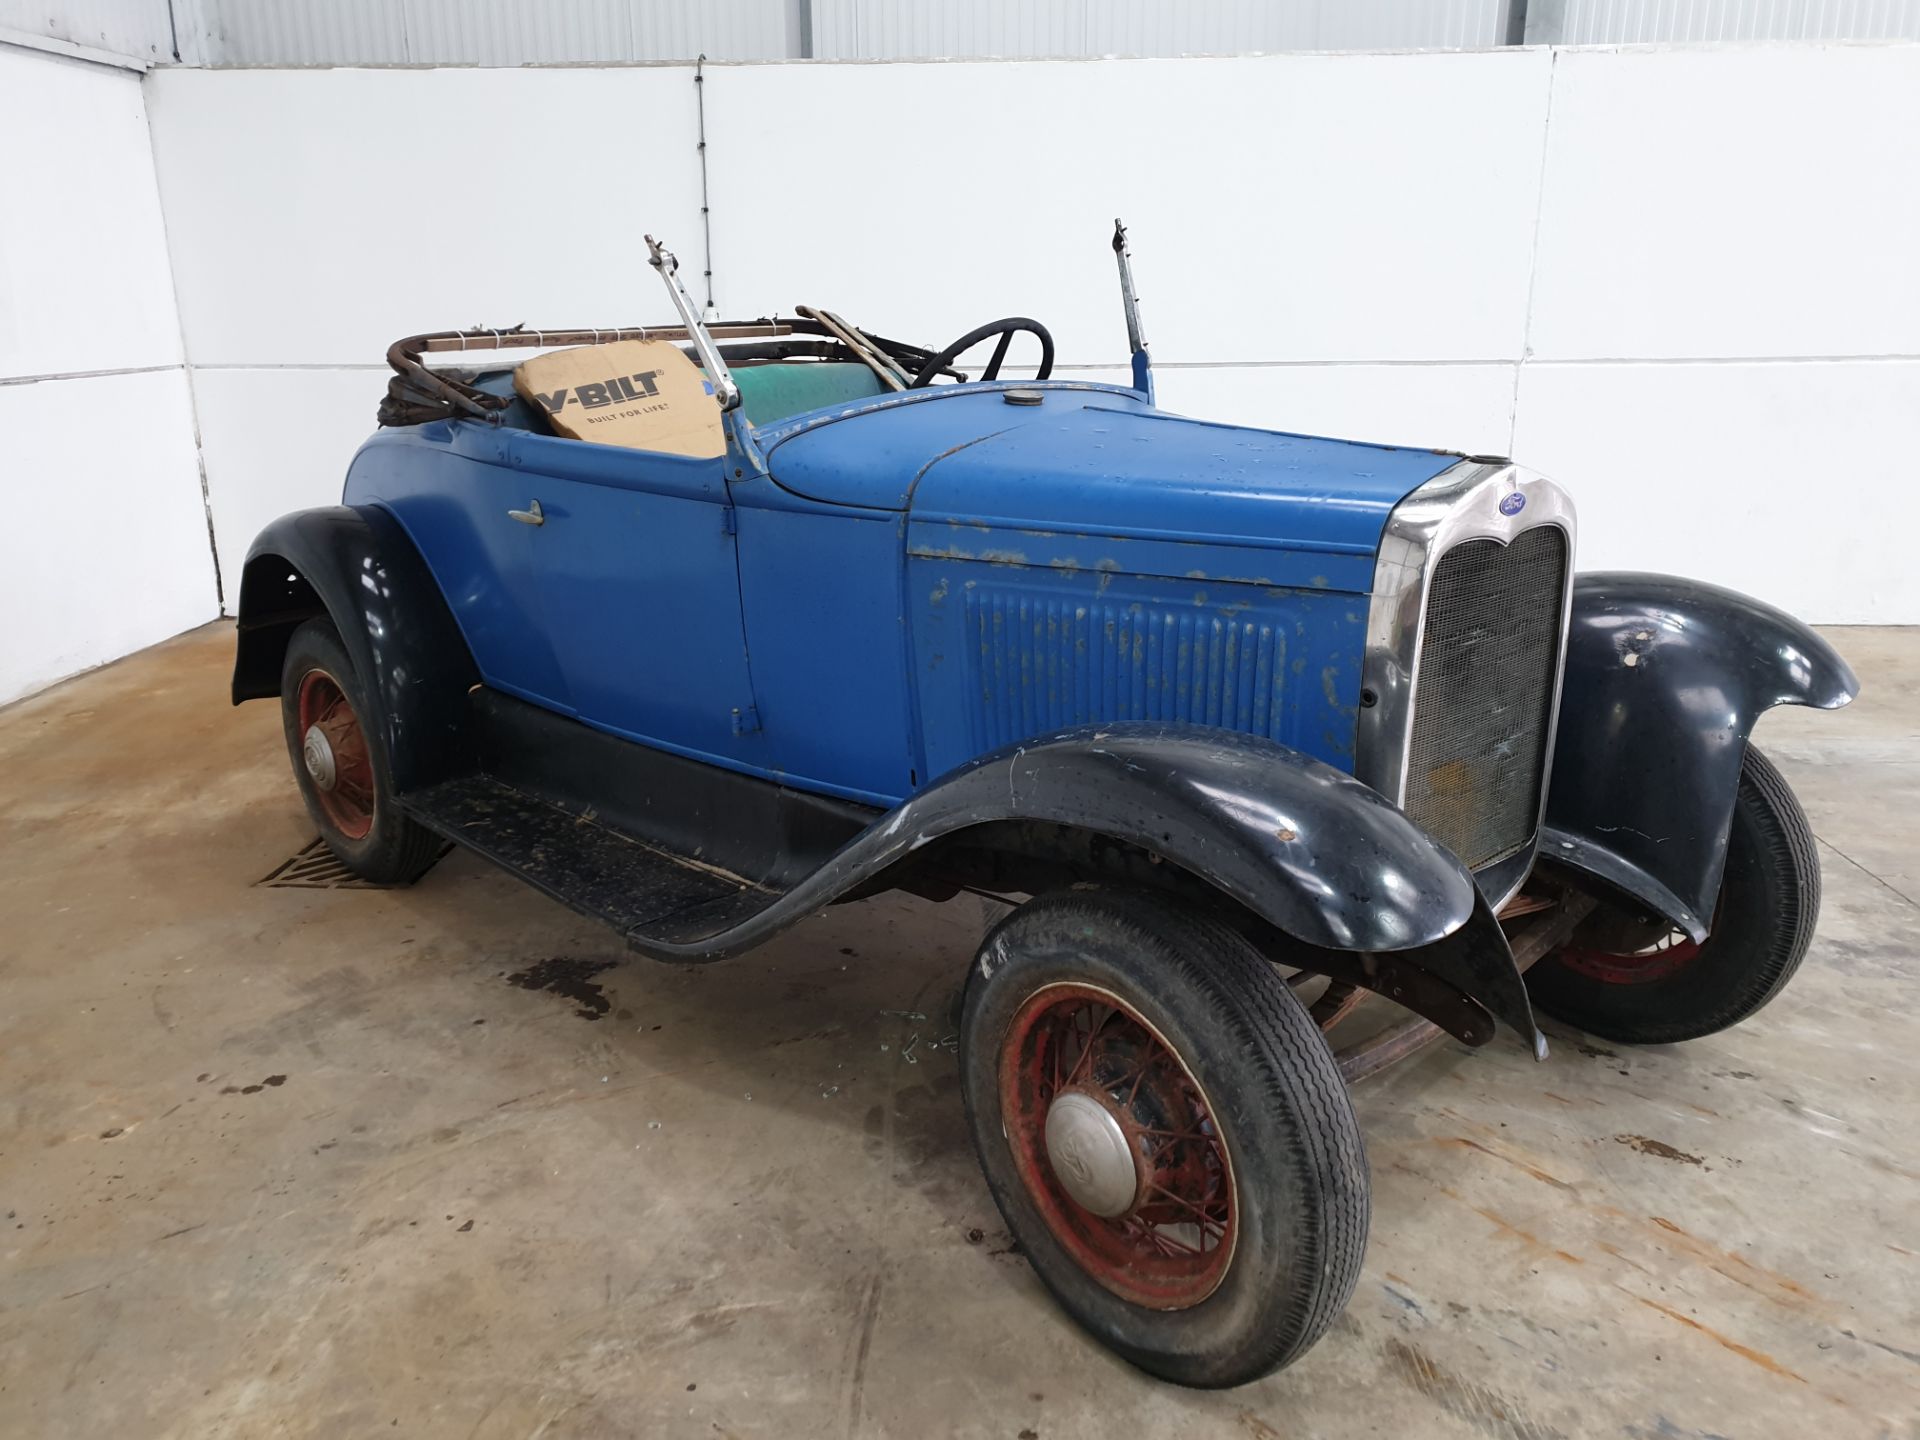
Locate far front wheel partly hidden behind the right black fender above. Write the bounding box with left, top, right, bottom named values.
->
left=1526, top=745, right=1820, bottom=1044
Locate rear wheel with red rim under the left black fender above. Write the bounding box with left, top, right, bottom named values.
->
left=280, top=620, right=440, bottom=885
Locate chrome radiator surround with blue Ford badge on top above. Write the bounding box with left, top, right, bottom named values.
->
left=1354, top=459, right=1576, bottom=908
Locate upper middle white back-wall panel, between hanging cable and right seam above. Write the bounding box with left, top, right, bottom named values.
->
left=708, top=50, right=1549, bottom=363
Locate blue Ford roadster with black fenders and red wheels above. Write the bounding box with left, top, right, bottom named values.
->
left=234, top=228, right=1855, bottom=1384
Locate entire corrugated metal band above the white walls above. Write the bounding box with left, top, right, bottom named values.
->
left=0, top=0, right=1920, bottom=65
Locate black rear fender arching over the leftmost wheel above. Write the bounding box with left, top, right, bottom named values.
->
left=232, top=505, right=480, bottom=791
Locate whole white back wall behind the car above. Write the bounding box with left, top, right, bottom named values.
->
left=150, top=48, right=1920, bottom=622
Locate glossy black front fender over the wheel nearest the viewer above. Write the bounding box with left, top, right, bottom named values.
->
left=645, top=724, right=1540, bottom=1050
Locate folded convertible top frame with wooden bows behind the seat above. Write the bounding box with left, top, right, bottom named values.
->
left=380, top=315, right=966, bottom=426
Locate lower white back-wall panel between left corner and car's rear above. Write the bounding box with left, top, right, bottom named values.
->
left=194, top=371, right=386, bottom=587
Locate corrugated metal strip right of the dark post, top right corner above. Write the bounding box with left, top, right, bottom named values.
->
left=1526, top=0, right=1920, bottom=44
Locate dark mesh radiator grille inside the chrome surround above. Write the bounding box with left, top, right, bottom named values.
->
left=1405, top=526, right=1567, bottom=870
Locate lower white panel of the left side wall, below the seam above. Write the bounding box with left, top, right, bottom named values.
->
left=0, top=371, right=219, bottom=705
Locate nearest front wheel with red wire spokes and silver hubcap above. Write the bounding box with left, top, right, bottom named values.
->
left=960, top=891, right=1367, bottom=1386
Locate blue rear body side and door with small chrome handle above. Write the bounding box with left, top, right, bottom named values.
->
left=348, top=420, right=762, bottom=768
